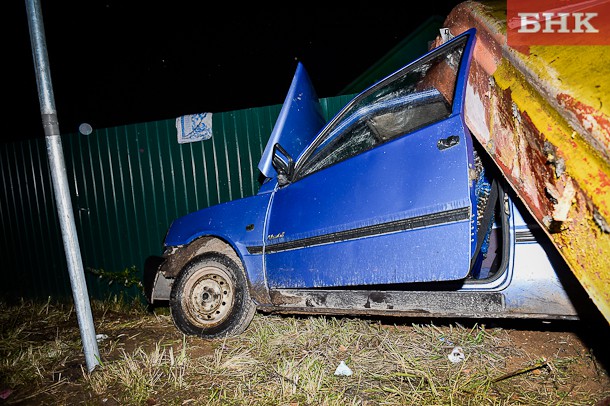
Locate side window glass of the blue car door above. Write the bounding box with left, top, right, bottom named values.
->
left=294, top=37, right=467, bottom=180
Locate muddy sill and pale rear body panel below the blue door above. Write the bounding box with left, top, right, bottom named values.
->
left=263, top=196, right=583, bottom=320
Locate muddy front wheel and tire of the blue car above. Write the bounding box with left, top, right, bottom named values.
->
left=169, top=253, right=256, bottom=338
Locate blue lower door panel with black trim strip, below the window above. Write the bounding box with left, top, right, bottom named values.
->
left=265, top=112, right=471, bottom=288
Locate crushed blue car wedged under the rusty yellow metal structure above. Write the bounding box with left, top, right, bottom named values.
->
left=144, top=29, right=578, bottom=338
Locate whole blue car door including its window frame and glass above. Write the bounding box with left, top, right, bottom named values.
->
left=263, top=31, right=476, bottom=288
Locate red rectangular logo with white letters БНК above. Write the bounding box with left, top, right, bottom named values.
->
left=506, top=0, right=610, bottom=48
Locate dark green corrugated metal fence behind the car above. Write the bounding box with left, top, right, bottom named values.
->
left=0, top=95, right=352, bottom=300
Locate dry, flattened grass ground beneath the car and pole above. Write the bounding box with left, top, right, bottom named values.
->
left=0, top=299, right=610, bottom=406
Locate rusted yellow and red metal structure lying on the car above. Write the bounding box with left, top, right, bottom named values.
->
left=437, top=1, right=610, bottom=321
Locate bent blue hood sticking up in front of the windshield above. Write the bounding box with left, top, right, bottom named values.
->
left=258, top=62, right=325, bottom=178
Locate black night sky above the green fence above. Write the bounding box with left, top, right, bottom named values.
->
left=11, top=0, right=459, bottom=144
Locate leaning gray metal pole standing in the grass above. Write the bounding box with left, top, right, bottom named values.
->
left=25, top=0, right=100, bottom=372
